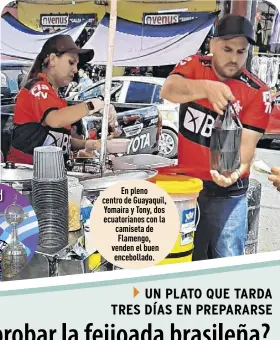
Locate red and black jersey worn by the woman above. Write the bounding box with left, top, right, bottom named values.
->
left=10, top=73, right=71, bottom=159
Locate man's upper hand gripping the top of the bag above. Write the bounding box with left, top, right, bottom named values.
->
left=204, top=80, right=235, bottom=115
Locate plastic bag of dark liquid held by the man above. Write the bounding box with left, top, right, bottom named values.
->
left=210, top=103, right=242, bottom=175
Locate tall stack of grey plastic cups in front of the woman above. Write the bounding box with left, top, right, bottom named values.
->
left=32, top=146, right=68, bottom=254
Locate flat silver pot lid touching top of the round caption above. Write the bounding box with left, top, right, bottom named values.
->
left=81, top=170, right=157, bottom=191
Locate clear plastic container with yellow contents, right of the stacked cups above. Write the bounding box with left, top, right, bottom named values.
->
left=68, top=177, right=83, bottom=231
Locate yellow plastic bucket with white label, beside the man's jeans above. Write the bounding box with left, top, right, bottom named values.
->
left=149, top=175, right=203, bottom=265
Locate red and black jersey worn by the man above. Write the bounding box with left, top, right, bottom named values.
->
left=171, top=55, right=271, bottom=181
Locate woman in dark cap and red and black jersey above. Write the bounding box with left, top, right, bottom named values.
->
left=8, top=35, right=116, bottom=164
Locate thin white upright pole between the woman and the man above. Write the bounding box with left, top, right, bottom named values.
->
left=100, top=0, right=117, bottom=173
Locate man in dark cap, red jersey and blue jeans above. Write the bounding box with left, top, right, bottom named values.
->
left=161, top=15, right=271, bottom=261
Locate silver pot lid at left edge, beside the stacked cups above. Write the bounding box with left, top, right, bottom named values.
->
left=0, top=162, right=33, bottom=182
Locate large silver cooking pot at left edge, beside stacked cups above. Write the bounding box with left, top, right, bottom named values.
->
left=0, top=162, right=33, bottom=205
